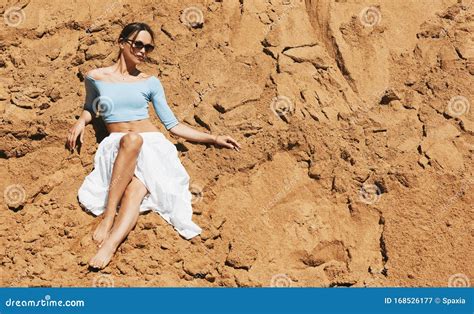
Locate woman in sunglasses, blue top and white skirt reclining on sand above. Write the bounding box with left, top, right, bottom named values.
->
left=67, top=23, right=240, bottom=269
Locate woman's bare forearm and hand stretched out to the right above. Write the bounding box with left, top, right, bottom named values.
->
left=169, top=123, right=240, bottom=151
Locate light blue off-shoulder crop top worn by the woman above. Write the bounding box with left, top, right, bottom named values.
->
left=84, top=75, right=179, bottom=130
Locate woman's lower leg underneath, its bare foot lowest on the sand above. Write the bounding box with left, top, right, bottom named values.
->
left=89, top=176, right=148, bottom=269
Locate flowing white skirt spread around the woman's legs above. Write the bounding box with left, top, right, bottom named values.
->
left=77, top=132, right=202, bottom=239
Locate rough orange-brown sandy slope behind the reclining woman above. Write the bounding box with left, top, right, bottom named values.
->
left=0, top=0, right=474, bottom=286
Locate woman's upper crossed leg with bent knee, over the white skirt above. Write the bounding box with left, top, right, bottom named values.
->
left=92, top=132, right=143, bottom=244
